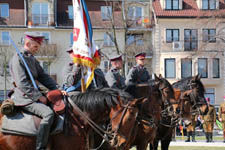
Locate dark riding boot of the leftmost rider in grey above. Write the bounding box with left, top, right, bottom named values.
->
left=36, top=124, right=50, bottom=150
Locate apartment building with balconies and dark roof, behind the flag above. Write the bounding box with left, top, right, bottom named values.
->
left=0, top=0, right=152, bottom=99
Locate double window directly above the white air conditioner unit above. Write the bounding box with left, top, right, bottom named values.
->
left=166, top=29, right=179, bottom=43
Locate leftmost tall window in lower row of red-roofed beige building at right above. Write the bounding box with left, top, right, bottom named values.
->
left=165, top=58, right=176, bottom=78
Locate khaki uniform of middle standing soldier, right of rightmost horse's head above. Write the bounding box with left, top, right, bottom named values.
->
left=202, top=104, right=216, bottom=142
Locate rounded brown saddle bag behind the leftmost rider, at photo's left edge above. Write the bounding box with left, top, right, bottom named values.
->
left=0, top=99, right=14, bottom=115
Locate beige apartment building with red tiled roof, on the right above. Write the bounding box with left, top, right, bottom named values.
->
left=153, top=0, right=225, bottom=105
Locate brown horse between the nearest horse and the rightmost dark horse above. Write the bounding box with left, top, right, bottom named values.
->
left=124, top=75, right=179, bottom=150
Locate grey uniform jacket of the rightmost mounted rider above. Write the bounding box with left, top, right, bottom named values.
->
left=125, top=65, right=150, bottom=85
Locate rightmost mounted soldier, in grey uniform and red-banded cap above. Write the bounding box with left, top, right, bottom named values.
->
left=125, top=52, right=150, bottom=85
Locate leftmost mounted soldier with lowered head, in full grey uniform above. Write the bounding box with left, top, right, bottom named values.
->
left=10, top=32, right=62, bottom=150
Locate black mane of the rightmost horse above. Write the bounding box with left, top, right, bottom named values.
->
left=172, top=77, right=205, bottom=92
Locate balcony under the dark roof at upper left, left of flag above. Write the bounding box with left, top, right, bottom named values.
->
left=28, top=14, right=55, bottom=27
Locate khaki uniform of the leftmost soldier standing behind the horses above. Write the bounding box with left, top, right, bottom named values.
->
left=185, top=115, right=198, bottom=142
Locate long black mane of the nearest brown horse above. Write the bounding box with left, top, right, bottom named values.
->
left=71, top=88, right=132, bottom=112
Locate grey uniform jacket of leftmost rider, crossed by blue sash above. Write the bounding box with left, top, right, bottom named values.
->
left=10, top=49, right=57, bottom=106
